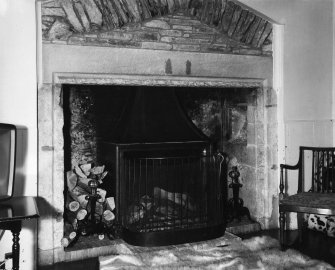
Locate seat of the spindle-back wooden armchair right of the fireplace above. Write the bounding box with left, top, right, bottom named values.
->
left=279, top=192, right=335, bottom=215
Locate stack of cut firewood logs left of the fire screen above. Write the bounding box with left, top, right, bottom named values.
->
left=61, top=164, right=115, bottom=247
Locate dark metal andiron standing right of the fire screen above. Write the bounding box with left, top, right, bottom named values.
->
left=228, top=166, right=252, bottom=222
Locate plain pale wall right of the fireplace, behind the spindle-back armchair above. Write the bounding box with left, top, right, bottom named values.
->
left=240, top=0, right=335, bottom=228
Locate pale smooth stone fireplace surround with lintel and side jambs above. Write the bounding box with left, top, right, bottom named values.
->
left=38, top=43, right=278, bottom=265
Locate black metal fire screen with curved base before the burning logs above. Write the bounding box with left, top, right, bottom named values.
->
left=98, top=144, right=227, bottom=246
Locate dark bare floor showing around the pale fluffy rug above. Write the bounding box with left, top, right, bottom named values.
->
left=38, top=230, right=335, bottom=270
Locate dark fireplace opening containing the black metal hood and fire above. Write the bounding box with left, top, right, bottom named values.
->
left=62, top=85, right=258, bottom=245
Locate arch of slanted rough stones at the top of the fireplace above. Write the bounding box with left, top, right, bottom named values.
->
left=42, top=0, right=272, bottom=48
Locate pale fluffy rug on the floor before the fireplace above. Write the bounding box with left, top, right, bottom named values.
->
left=99, top=233, right=335, bottom=270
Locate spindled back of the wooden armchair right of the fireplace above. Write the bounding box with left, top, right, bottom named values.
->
left=298, top=146, right=335, bottom=193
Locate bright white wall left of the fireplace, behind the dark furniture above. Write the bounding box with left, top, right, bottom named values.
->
left=0, top=0, right=37, bottom=270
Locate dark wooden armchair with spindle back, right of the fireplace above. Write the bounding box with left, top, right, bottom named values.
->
left=279, top=146, right=335, bottom=249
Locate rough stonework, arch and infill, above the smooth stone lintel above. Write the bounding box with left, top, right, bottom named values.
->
left=42, top=0, right=272, bottom=55
